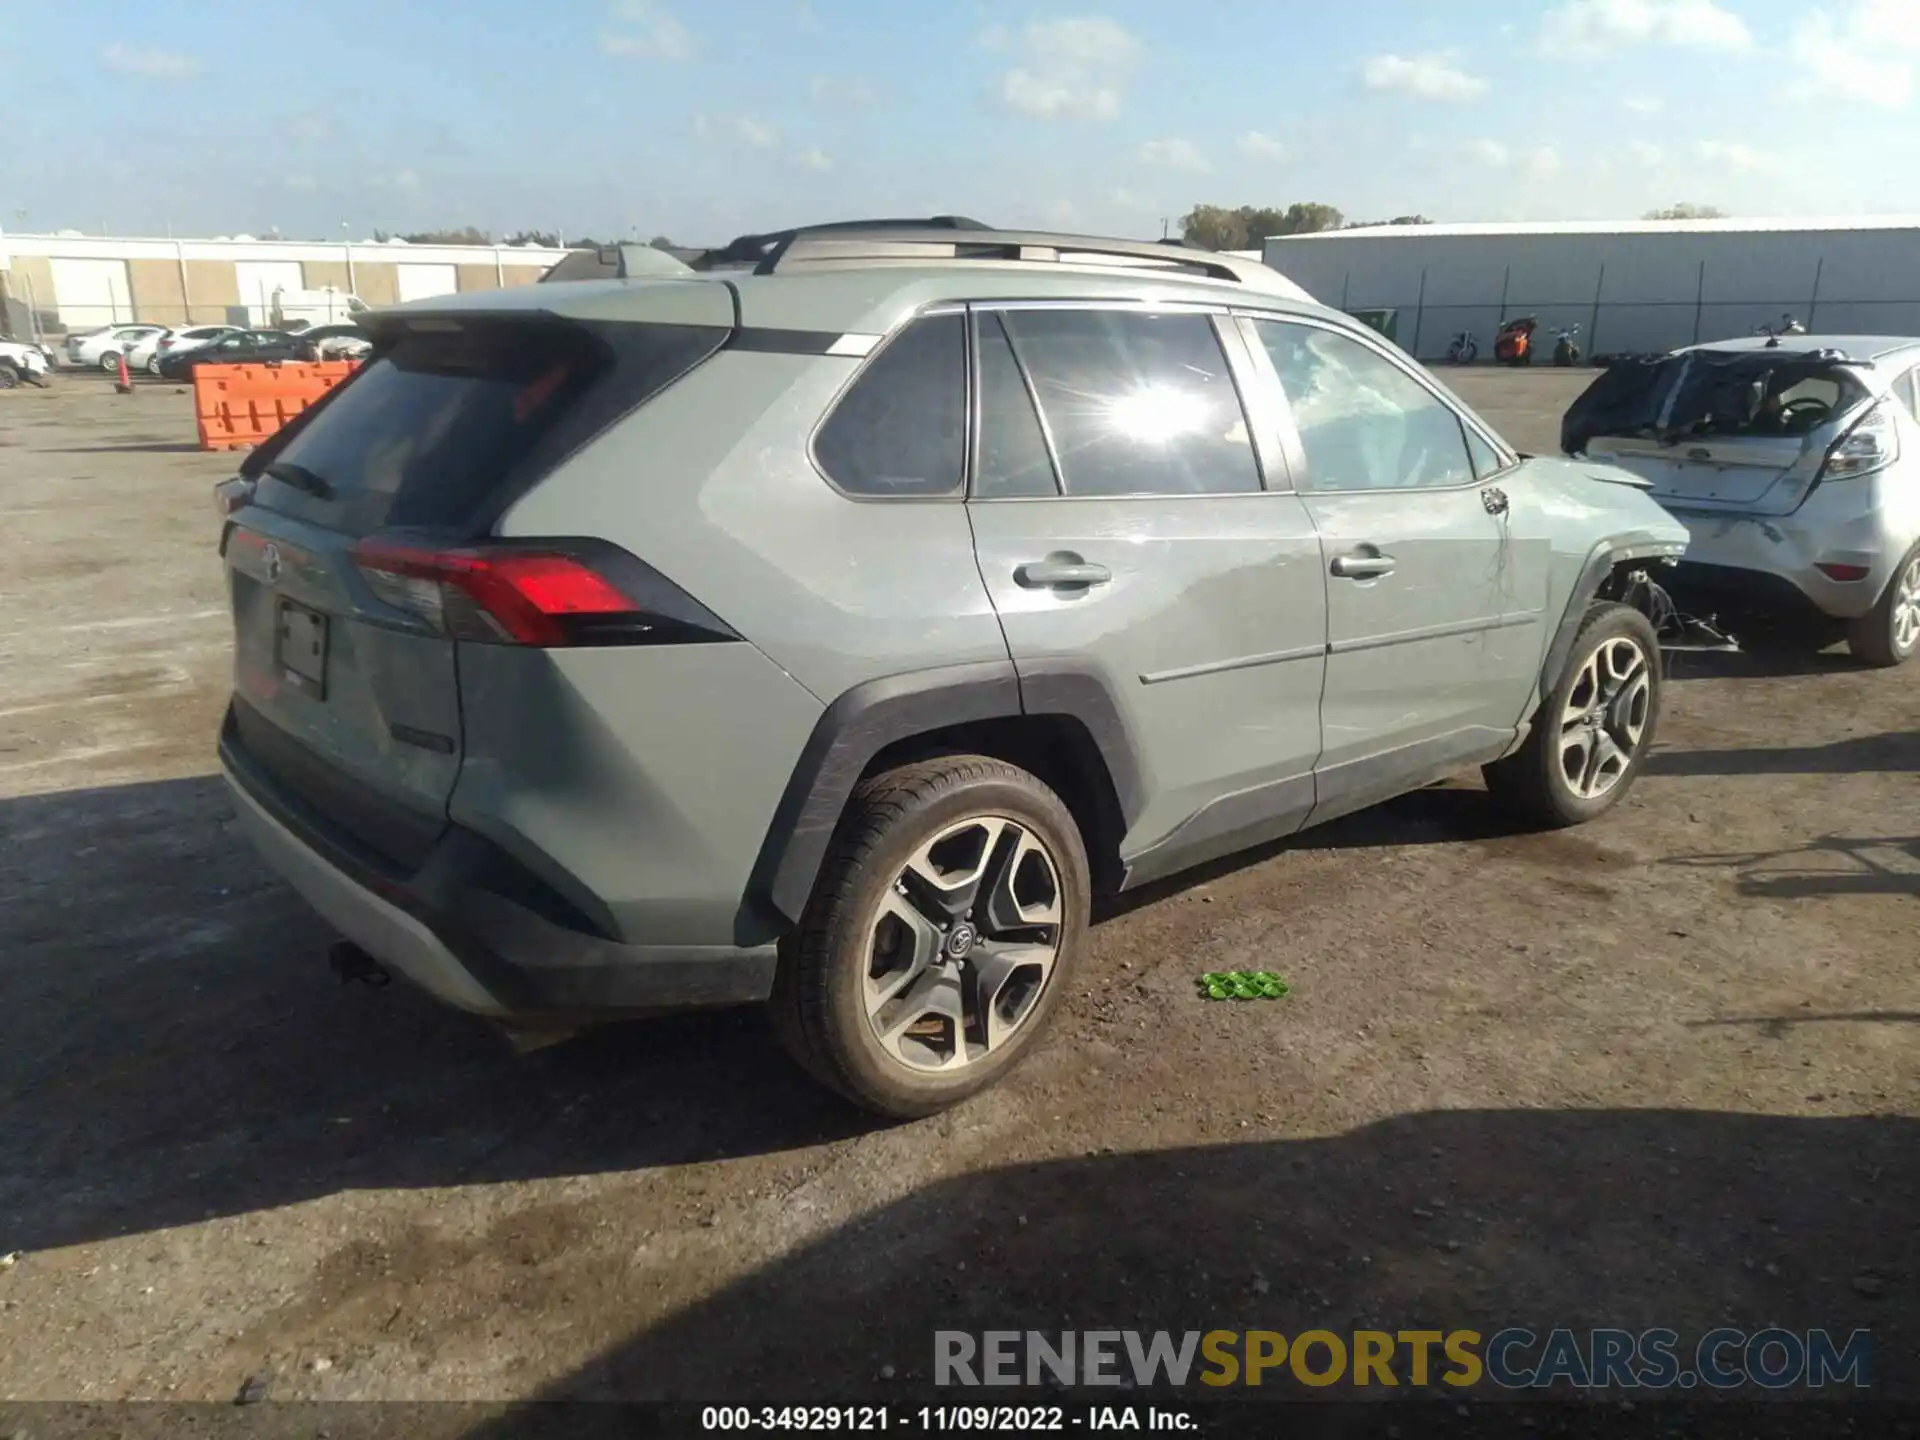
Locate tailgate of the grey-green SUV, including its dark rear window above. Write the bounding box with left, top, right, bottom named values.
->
left=225, top=301, right=732, bottom=864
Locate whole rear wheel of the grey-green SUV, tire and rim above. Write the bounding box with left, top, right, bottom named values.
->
left=772, top=755, right=1092, bottom=1119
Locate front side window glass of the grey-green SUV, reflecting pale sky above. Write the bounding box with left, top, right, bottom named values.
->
left=1256, top=321, right=1475, bottom=492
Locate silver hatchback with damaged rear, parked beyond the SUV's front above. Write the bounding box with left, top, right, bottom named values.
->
left=1561, top=334, right=1920, bottom=664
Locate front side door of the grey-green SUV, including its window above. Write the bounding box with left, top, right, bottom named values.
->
left=1254, top=319, right=1544, bottom=822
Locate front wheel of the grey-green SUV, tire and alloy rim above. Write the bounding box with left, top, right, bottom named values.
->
left=1480, top=601, right=1665, bottom=829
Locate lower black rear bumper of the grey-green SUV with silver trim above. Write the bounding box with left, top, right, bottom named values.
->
left=221, top=710, right=776, bottom=1025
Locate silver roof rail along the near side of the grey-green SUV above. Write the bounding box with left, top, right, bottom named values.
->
left=735, top=223, right=1311, bottom=300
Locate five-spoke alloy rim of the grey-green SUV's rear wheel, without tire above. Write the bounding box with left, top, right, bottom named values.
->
left=864, top=816, right=1066, bottom=1071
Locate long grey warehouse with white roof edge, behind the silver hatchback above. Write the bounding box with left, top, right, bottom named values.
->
left=1263, top=215, right=1920, bottom=359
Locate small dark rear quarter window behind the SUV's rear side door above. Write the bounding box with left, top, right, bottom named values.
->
left=814, top=315, right=966, bottom=495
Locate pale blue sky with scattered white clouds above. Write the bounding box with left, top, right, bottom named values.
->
left=0, top=0, right=1920, bottom=242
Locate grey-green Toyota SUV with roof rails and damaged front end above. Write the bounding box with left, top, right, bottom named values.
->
left=210, top=223, right=1688, bottom=1116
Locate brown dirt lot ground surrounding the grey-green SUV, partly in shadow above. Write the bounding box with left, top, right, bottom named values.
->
left=0, top=371, right=1920, bottom=1400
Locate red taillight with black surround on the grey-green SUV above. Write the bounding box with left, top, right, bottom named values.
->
left=353, top=540, right=737, bottom=649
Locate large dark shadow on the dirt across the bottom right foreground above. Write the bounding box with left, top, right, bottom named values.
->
left=468, top=1100, right=1920, bottom=1413
